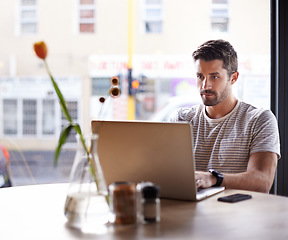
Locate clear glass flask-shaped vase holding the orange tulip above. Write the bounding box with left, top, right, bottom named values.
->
left=64, top=134, right=111, bottom=233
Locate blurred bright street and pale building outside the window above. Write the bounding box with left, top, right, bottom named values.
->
left=0, top=0, right=270, bottom=186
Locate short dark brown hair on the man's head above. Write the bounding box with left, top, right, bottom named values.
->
left=192, top=39, right=238, bottom=75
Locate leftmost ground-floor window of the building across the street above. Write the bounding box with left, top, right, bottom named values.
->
left=2, top=99, right=18, bottom=135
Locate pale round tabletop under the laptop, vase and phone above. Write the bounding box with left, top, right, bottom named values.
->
left=0, top=184, right=288, bottom=240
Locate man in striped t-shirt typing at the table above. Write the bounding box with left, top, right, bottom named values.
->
left=170, top=40, right=280, bottom=193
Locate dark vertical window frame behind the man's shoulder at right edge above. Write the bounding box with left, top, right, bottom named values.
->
left=270, top=0, right=288, bottom=196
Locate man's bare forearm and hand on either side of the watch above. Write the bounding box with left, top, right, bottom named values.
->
left=195, top=152, right=278, bottom=193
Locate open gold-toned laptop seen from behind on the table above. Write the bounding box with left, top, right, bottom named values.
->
left=91, top=120, right=224, bottom=201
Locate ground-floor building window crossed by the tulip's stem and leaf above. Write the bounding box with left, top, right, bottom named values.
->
left=61, top=101, right=78, bottom=143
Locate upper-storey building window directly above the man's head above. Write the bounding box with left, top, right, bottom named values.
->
left=211, top=0, right=229, bottom=32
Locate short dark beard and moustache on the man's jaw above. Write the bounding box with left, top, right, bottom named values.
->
left=200, top=82, right=231, bottom=106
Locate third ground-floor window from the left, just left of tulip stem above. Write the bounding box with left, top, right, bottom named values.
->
left=42, top=99, right=56, bottom=135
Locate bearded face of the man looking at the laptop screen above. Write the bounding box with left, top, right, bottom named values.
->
left=195, top=59, right=237, bottom=106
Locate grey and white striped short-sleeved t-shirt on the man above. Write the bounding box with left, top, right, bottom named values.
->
left=169, top=100, right=280, bottom=173
